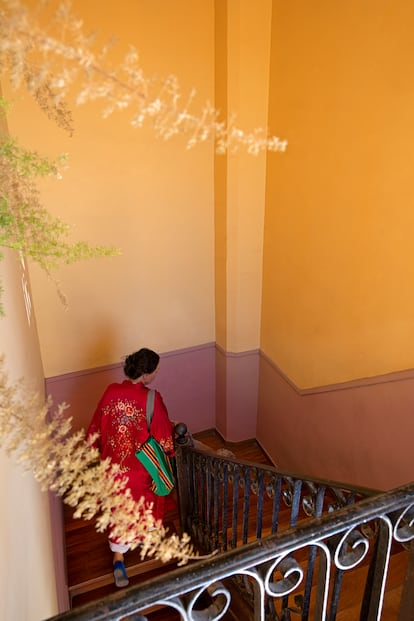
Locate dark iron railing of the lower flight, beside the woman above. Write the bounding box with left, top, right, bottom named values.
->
left=177, top=428, right=378, bottom=552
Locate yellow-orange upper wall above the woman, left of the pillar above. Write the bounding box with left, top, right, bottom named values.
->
left=3, top=0, right=215, bottom=377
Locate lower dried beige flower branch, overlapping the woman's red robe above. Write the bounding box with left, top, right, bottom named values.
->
left=0, top=357, right=198, bottom=565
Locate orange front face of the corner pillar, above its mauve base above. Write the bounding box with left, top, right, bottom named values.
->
left=226, top=0, right=272, bottom=352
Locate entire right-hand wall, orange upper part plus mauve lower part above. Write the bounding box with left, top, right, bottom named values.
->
left=257, top=0, right=414, bottom=489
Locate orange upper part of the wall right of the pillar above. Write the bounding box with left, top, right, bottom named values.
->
left=261, top=0, right=414, bottom=388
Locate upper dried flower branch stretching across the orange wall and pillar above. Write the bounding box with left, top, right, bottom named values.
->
left=0, top=0, right=287, bottom=155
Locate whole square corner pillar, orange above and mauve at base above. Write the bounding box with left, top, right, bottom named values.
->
left=215, top=0, right=272, bottom=442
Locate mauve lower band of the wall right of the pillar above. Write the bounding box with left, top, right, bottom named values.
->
left=257, top=355, right=414, bottom=490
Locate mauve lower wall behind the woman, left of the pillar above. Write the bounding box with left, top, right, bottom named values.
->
left=46, top=343, right=216, bottom=433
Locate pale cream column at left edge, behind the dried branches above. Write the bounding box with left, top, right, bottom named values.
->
left=0, top=91, right=58, bottom=621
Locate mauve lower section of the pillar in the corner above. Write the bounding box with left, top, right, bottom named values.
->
left=216, top=347, right=259, bottom=442
